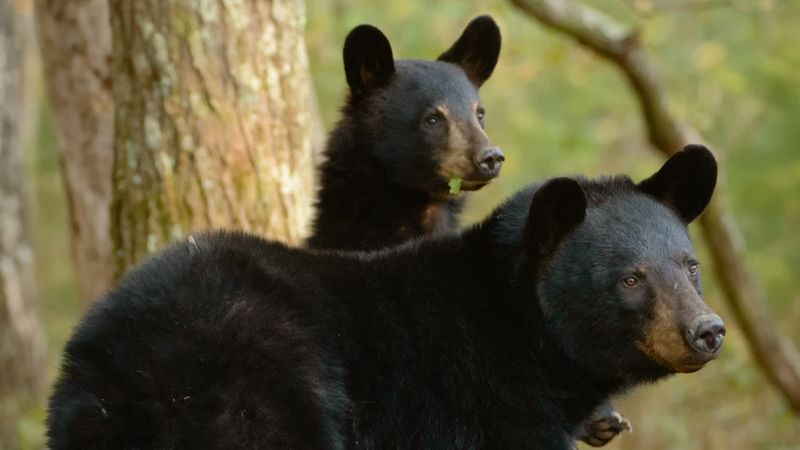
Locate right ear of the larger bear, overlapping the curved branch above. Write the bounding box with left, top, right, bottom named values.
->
left=639, top=145, right=717, bottom=224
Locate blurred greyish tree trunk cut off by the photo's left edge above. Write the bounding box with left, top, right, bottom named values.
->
left=0, top=0, right=44, bottom=448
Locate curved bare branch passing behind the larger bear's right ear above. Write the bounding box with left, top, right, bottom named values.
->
left=512, top=0, right=800, bottom=413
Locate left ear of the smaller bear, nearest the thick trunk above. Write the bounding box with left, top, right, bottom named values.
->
left=342, top=25, right=395, bottom=95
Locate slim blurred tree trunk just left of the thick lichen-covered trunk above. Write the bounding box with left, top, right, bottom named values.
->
left=36, top=0, right=114, bottom=302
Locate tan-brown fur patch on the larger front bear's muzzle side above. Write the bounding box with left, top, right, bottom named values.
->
left=636, top=300, right=700, bottom=373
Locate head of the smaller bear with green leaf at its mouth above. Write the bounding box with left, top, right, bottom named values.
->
left=344, top=16, right=505, bottom=193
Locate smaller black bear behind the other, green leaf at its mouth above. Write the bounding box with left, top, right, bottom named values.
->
left=308, top=16, right=505, bottom=250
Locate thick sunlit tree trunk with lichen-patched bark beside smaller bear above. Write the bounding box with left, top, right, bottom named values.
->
left=110, top=0, right=313, bottom=273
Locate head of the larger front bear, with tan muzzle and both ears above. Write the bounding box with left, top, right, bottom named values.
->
left=525, top=145, right=725, bottom=384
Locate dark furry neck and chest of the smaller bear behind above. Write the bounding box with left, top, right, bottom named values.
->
left=308, top=118, right=463, bottom=250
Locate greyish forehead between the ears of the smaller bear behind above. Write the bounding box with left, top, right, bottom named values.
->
left=390, top=59, right=478, bottom=104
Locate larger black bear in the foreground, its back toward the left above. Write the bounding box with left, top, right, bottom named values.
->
left=48, top=146, right=725, bottom=450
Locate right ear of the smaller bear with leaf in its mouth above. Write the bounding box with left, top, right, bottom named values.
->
left=439, top=16, right=500, bottom=87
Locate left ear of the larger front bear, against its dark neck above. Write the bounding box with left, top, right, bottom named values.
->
left=525, top=178, right=586, bottom=256
